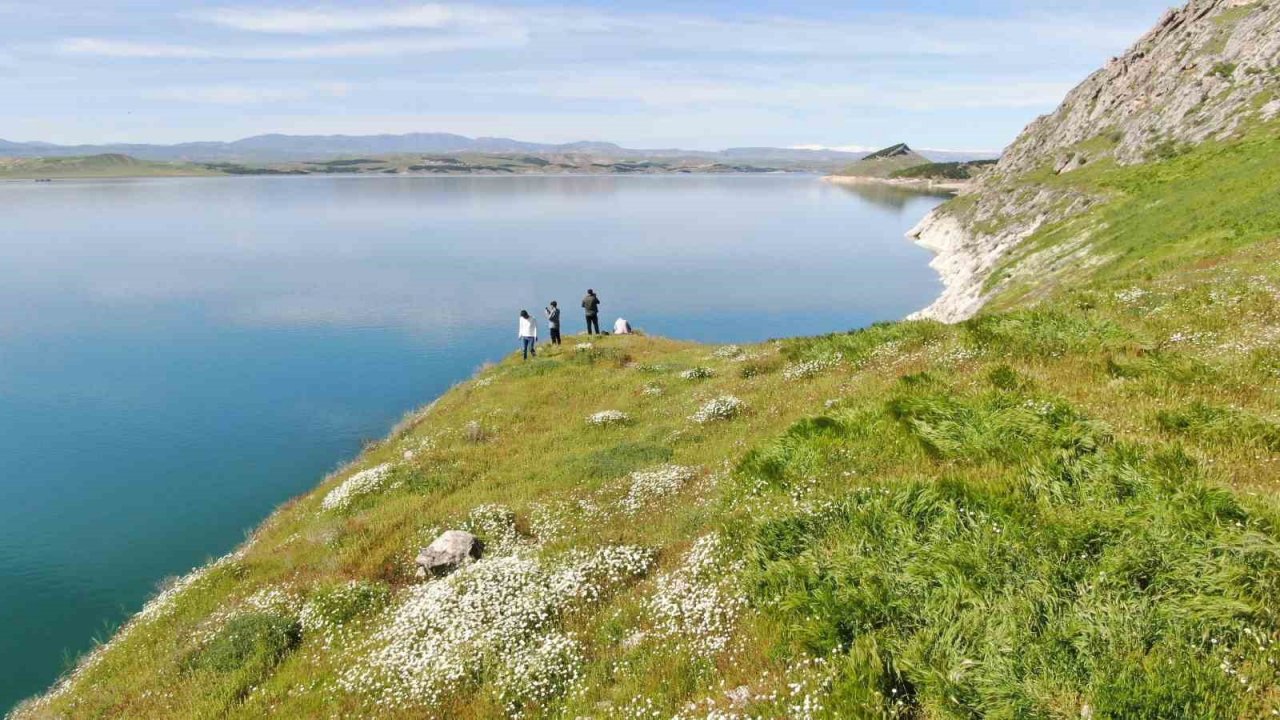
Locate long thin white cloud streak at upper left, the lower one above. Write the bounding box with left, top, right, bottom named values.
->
left=58, top=33, right=526, bottom=60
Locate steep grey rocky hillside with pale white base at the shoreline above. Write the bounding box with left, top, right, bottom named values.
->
left=911, top=0, right=1280, bottom=322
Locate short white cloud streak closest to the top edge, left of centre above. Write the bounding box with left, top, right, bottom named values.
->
left=195, top=3, right=515, bottom=35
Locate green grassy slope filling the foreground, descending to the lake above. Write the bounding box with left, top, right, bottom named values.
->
left=15, top=120, right=1280, bottom=719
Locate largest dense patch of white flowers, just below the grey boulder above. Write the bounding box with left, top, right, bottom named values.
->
left=339, top=547, right=653, bottom=714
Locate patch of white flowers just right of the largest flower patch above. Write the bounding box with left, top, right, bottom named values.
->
left=648, top=534, right=746, bottom=657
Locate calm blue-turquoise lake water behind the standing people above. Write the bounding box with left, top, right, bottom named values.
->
left=0, top=176, right=941, bottom=708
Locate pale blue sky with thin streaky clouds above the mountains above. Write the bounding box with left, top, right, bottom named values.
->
left=0, top=0, right=1170, bottom=150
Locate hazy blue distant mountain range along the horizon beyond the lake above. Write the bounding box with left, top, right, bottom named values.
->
left=0, top=132, right=993, bottom=165
